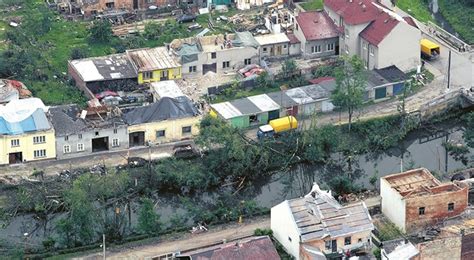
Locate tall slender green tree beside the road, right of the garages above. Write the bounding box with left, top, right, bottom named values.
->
left=331, top=55, right=367, bottom=132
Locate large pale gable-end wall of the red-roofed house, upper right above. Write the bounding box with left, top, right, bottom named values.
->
left=375, top=22, right=421, bottom=71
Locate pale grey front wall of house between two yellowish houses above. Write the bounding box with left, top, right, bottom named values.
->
left=56, top=125, right=129, bottom=159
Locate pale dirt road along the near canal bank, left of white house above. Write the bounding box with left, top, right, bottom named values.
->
left=78, top=216, right=270, bottom=260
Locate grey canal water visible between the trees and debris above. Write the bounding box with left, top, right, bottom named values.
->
left=0, top=126, right=473, bottom=250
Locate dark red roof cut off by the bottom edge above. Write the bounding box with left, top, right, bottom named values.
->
left=183, top=236, right=280, bottom=260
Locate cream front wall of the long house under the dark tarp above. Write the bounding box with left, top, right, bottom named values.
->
left=128, top=116, right=201, bottom=144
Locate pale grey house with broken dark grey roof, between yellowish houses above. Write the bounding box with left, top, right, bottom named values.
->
left=49, top=105, right=129, bottom=159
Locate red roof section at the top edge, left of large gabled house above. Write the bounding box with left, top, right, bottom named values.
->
left=324, top=0, right=381, bottom=25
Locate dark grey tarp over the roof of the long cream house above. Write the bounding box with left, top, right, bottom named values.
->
left=124, top=97, right=199, bottom=125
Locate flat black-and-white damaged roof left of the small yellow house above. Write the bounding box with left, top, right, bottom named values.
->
left=69, top=53, right=137, bottom=82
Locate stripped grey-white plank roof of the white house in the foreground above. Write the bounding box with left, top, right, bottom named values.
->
left=286, top=184, right=374, bottom=242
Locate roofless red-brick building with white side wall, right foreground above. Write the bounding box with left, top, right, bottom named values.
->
left=380, top=168, right=469, bottom=233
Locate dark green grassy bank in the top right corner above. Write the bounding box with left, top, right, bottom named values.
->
left=438, top=0, right=474, bottom=44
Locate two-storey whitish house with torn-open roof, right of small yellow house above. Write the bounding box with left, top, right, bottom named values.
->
left=169, top=32, right=259, bottom=76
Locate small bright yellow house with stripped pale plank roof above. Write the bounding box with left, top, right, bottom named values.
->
left=127, top=47, right=181, bottom=84
